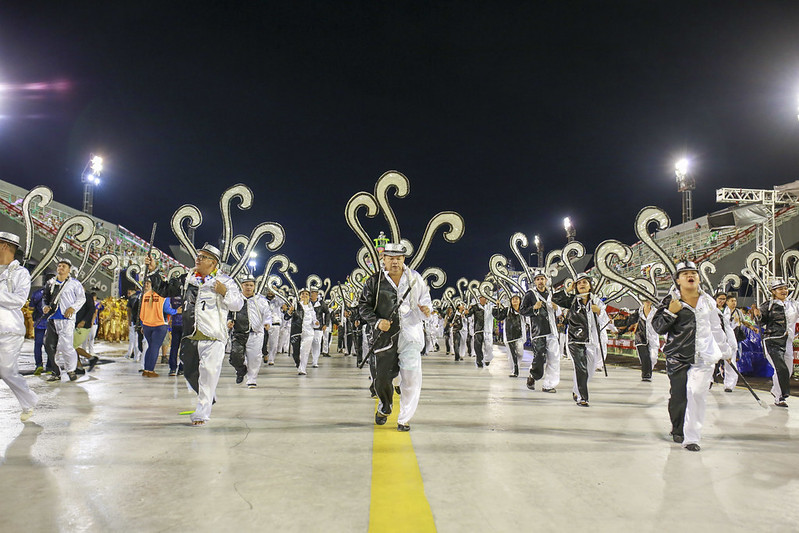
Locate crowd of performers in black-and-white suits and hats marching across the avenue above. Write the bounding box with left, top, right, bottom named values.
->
left=0, top=232, right=799, bottom=451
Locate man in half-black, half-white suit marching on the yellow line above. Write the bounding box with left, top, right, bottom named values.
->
left=358, top=243, right=432, bottom=431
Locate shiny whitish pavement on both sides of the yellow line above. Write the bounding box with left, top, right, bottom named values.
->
left=0, top=343, right=799, bottom=532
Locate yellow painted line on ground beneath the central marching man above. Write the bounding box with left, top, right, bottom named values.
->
left=369, top=395, right=436, bottom=533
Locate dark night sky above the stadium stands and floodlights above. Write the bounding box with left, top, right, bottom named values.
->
left=0, top=0, right=799, bottom=290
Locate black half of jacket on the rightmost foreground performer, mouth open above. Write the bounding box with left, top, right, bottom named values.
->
left=652, top=295, right=696, bottom=375
